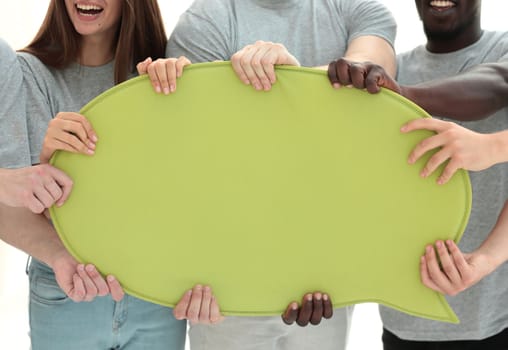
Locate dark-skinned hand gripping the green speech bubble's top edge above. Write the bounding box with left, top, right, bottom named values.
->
left=328, top=58, right=401, bottom=94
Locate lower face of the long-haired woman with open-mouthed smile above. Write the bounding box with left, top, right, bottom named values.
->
left=65, top=0, right=123, bottom=37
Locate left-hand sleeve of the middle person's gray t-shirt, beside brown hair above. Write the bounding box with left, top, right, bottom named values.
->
left=166, top=0, right=234, bottom=63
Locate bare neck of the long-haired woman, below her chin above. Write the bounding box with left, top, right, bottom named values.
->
left=78, top=35, right=115, bottom=67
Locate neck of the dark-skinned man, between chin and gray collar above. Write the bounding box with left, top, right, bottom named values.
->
left=426, top=23, right=483, bottom=53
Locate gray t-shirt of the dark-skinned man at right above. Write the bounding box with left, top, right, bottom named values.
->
left=380, top=32, right=508, bottom=341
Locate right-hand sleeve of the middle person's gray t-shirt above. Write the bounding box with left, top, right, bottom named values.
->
left=341, top=0, right=397, bottom=47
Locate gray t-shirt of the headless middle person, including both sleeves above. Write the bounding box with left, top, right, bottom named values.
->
left=166, top=0, right=396, bottom=67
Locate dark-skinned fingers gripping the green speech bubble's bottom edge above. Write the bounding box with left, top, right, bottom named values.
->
left=282, top=292, right=333, bottom=327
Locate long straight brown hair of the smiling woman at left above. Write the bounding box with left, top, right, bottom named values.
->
left=20, top=0, right=167, bottom=83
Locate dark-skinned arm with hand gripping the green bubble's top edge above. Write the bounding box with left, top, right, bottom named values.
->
left=328, top=59, right=508, bottom=121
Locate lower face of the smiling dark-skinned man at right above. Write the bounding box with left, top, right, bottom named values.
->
left=415, top=0, right=482, bottom=52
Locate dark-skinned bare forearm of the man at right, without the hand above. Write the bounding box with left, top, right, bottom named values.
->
left=401, top=62, right=508, bottom=121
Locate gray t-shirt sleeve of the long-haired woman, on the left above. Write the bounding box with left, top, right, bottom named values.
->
left=18, top=53, right=53, bottom=164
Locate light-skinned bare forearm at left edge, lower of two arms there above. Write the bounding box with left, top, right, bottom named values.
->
left=0, top=204, right=66, bottom=266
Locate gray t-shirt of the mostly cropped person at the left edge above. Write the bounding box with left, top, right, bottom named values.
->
left=0, top=39, right=30, bottom=168
